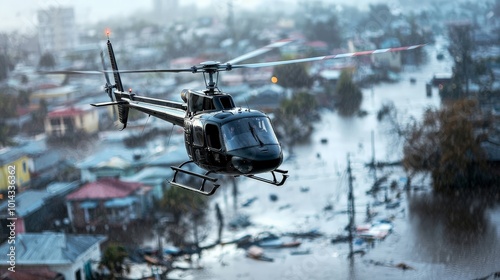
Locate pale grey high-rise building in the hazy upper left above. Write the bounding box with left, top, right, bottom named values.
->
left=38, top=7, right=78, bottom=53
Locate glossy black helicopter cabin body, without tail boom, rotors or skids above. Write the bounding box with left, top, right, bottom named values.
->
left=182, top=91, right=283, bottom=175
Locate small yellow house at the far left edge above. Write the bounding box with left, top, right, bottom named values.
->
left=0, top=148, right=31, bottom=193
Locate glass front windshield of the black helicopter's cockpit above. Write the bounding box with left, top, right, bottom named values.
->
left=221, top=117, right=278, bottom=151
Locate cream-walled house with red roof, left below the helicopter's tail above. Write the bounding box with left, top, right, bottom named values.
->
left=44, top=106, right=99, bottom=137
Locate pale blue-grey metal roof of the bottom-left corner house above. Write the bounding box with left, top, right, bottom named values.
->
left=0, top=232, right=107, bottom=265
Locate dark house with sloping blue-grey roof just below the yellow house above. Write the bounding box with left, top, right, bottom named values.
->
left=0, top=182, right=79, bottom=237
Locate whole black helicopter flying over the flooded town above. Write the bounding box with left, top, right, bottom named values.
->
left=50, top=33, right=425, bottom=196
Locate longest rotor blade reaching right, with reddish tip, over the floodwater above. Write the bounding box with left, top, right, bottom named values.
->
left=231, top=44, right=426, bottom=69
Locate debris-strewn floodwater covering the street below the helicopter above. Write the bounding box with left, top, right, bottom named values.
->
left=174, top=44, right=500, bottom=279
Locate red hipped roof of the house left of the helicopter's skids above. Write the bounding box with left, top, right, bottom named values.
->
left=66, top=178, right=144, bottom=200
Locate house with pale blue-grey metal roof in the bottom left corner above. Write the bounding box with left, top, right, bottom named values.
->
left=0, top=232, right=107, bottom=280
